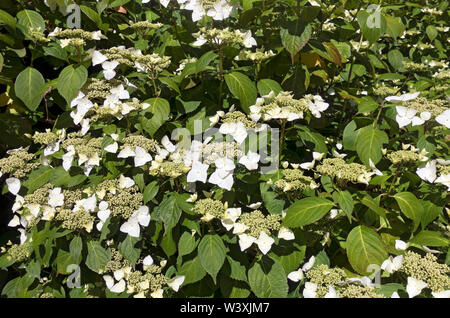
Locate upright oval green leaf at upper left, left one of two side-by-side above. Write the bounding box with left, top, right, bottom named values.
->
left=14, top=67, right=45, bottom=111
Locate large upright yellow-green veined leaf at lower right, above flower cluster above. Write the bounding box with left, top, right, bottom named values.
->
left=346, top=225, right=388, bottom=275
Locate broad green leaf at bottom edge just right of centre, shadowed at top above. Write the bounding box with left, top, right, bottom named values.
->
left=248, top=256, right=289, bottom=298
